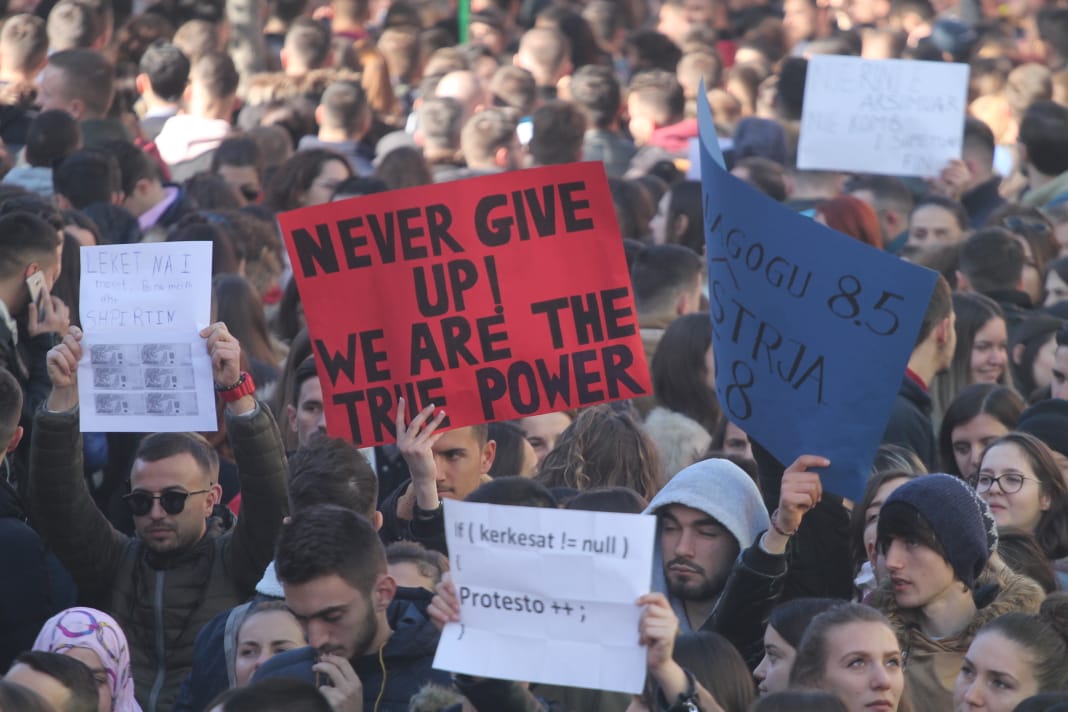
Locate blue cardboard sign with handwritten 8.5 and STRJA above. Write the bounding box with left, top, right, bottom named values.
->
left=698, top=93, right=938, bottom=500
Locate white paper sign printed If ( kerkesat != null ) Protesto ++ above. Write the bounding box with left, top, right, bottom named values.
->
left=434, top=500, right=656, bottom=694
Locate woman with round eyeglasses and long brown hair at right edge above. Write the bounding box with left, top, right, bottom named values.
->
left=974, top=432, right=1068, bottom=587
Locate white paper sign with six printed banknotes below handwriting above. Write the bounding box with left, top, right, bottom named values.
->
left=78, top=242, right=218, bottom=432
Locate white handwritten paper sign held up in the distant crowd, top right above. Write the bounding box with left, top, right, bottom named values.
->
left=798, top=54, right=968, bottom=176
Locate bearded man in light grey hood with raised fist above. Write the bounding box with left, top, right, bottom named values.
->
left=645, top=455, right=830, bottom=667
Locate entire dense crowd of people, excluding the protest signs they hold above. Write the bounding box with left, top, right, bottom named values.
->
left=0, top=0, right=1068, bottom=712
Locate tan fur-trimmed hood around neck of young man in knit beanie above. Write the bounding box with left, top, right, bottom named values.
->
left=871, top=555, right=1046, bottom=653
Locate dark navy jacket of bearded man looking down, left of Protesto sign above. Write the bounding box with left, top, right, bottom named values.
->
left=252, top=588, right=452, bottom=712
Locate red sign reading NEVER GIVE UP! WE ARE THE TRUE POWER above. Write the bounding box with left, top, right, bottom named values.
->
left=279, top=162, right=651, bottom=446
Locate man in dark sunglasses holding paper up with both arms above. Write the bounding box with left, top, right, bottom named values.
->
left=29, top=323, right=286, bottom=712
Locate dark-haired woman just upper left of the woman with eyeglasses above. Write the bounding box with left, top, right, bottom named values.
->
left=939, top=383, right=1024, bottom=479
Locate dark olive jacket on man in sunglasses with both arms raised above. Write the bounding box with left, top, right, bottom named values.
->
left=28, top=408, right=286, bottom=712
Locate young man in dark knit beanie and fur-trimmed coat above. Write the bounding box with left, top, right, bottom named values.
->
left=871, top=474, right=1045, bottom=710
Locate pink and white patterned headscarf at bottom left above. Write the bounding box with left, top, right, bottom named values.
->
left=33, top=607, right=141, bottom=712
